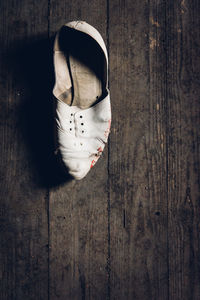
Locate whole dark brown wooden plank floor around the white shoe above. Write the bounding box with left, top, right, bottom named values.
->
left=0, top=0, right=200, bottom=300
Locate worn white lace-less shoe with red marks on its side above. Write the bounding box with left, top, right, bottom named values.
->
left=53, top=21, right=111, bottom=180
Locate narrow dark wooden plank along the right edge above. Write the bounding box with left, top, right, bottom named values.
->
left=166, top=0, right=200, bottom=300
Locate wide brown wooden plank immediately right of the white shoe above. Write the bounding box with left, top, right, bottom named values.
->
left=109, top=0, right=168, bottom=300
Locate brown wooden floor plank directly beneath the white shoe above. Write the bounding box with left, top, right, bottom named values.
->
left=50, top=0, right=108, bottom=300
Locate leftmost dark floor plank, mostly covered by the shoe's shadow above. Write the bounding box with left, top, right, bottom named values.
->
left=0, top=0, right=48, bottom=300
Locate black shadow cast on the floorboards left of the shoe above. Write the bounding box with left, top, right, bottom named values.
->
left=6, top=37, right=72, bottom=187
